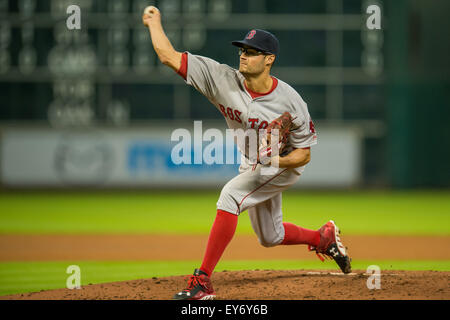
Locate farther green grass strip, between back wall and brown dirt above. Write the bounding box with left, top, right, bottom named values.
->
left=0, top=191, right=450, bottom=235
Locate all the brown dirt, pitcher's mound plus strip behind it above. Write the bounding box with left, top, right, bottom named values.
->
left=0, top=235, right=450, bottom=300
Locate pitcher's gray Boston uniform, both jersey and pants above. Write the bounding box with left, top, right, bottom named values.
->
left=179, top=52, right=317, bottom=246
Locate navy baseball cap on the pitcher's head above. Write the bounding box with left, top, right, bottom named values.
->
left=231, top=29, right=280, bottom=56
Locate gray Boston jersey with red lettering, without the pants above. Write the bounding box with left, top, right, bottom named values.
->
left=182, top=53, right=317, bottom=173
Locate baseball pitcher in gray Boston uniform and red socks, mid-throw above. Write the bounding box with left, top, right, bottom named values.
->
left=142, top=6, right=351, bottom=300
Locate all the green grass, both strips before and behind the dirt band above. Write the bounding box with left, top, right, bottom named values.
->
left=0, top=191, right=450, bottom=295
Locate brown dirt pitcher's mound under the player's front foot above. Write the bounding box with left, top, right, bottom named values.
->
left=0, top=270, right=450, bottom=300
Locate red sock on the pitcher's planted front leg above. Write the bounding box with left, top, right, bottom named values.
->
left=200, top=210, right=238, bottom=276
